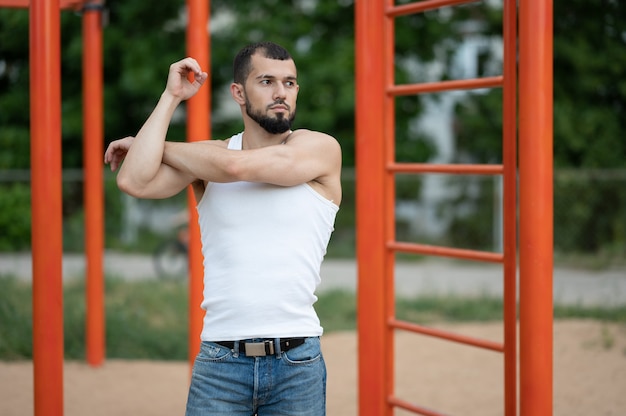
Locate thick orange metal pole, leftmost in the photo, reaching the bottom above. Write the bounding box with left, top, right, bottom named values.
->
left=29, top=0, right=63, bottom=415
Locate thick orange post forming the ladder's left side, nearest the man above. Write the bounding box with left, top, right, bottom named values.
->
left=355, top=0, right=392, bottom=416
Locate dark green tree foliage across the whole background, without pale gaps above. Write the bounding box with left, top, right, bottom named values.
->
left=0, top=0, right=626, bottom=260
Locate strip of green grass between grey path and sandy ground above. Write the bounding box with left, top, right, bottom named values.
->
left=0, top=276, right=626, bottom=360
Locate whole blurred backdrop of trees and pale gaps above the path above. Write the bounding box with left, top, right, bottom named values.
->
left=0, top=0, right=626, bottom=268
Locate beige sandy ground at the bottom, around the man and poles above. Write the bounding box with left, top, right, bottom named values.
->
left=0, top=321, right=626, bottom=416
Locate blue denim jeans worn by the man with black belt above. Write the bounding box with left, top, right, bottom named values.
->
left=186, top=337, right=326, bottom=416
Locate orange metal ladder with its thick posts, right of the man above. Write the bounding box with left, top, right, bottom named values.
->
left=356, top=0, right=552, bottom=416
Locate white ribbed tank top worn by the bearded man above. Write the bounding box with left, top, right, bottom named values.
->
left=197, top=133, right=339, bottom=341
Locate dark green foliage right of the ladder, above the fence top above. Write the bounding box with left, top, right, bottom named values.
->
left=554, top=0, right=626, bottom=168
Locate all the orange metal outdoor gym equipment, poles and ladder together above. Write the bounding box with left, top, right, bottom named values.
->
left=0, top=0, right=553, bottom=416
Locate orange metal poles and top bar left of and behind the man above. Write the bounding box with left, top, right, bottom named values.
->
left=0, top=0, right=211, bottom=416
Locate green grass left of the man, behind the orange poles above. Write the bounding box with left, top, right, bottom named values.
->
left=0, top=277, right=188, bottom=360
